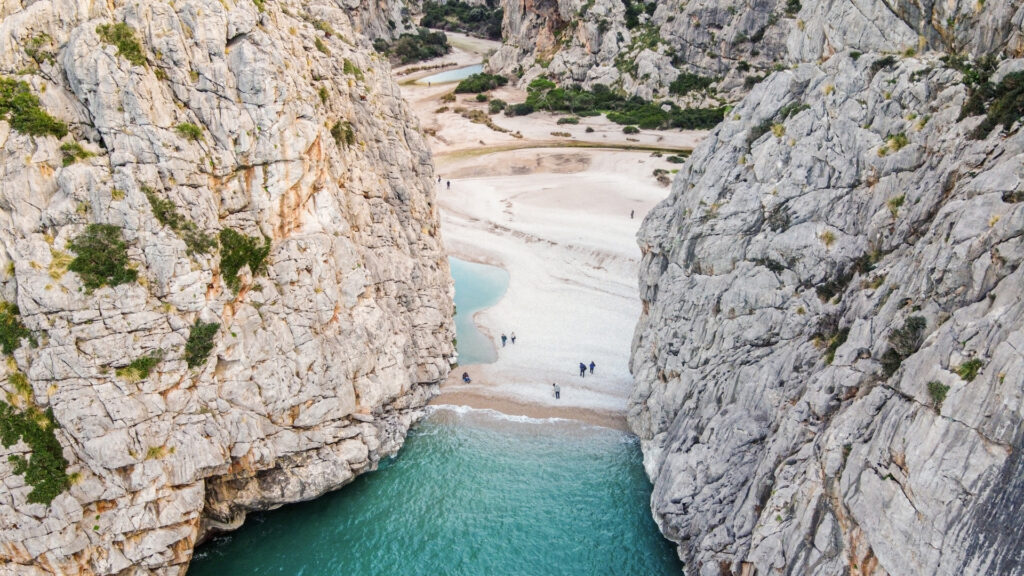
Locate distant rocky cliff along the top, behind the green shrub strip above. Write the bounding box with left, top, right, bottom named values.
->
left=489, top=0, right=1022, bottom=104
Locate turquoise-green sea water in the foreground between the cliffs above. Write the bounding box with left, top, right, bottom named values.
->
left=188, top=407, right=681, bottom=576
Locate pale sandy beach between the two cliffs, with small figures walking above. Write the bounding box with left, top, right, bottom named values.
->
left=399, top=34, right=703, bottom=429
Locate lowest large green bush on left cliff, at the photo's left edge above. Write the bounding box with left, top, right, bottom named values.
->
left=0, top=401, right=71, bottom=505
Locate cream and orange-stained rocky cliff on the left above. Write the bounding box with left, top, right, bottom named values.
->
left=0, top=0, right=454, bottom=574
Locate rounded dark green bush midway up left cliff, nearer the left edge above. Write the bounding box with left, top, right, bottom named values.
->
left=68, top=224, right=138, bottom=291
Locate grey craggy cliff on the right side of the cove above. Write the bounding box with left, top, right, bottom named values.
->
left=629, top=2, right=1024, bottom=576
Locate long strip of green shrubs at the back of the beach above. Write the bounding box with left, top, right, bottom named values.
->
left=506, top=78, right=725, bottom=130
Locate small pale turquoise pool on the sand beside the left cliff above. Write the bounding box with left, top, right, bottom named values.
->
left=449, top=258, right=509, bottom=366
